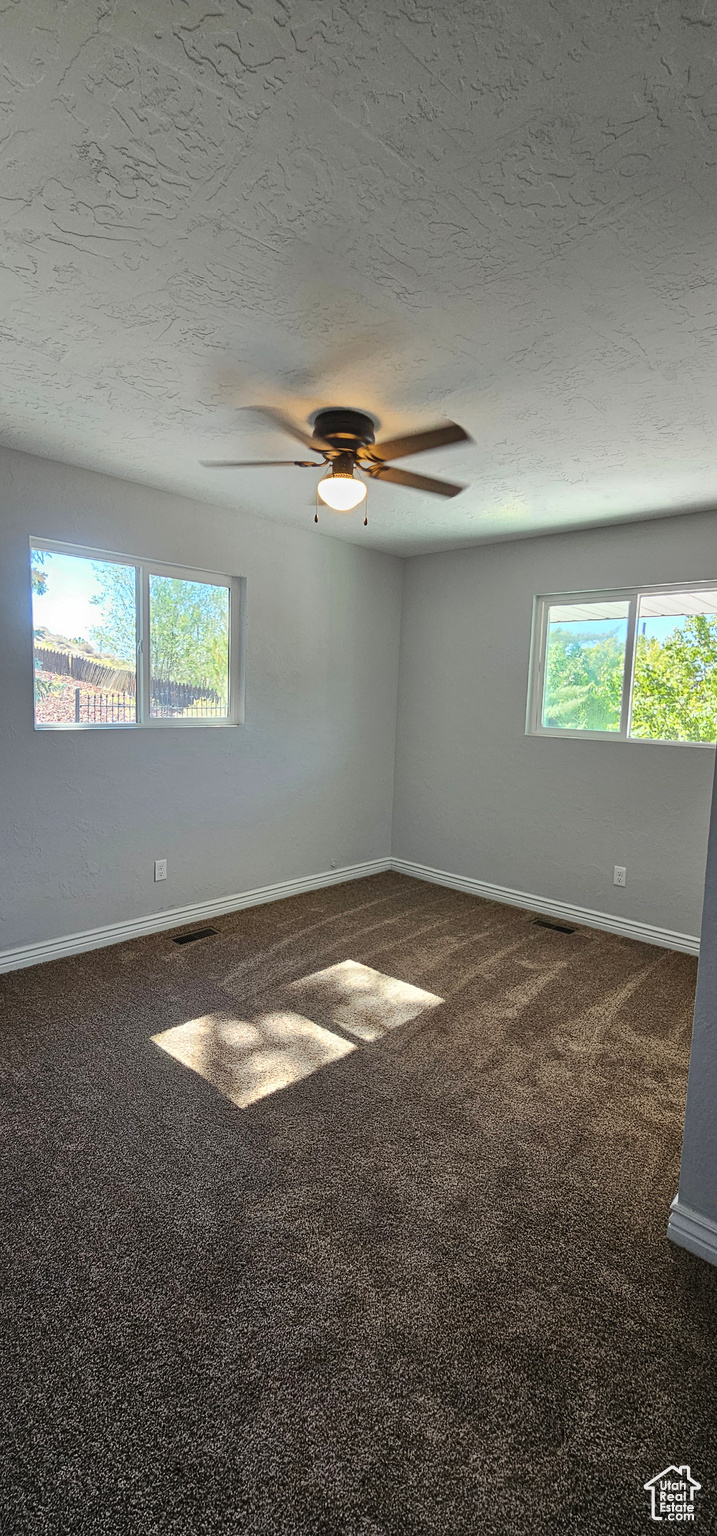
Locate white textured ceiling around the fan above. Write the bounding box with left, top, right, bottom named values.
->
left=0, top=0, right=717, bottom=553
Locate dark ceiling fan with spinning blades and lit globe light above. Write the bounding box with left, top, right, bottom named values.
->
left=201, top=406, right=471, bottom=511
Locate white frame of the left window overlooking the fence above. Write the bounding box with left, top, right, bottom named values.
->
left=29, top=536, right=246, bottom=731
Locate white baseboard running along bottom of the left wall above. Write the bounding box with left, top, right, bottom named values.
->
left=0, top=859, right=392, bottom=972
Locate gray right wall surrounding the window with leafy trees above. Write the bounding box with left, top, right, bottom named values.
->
left=393, top=513, right=717, bottom=934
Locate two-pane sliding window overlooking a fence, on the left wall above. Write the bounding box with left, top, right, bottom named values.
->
left=31, top=541, right=243, bottom=730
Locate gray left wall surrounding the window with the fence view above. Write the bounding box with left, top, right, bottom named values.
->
left=0, top=452, right=402, bottom=949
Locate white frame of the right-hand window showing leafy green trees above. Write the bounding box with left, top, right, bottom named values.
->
left=525, top=579, right=717, bottom=753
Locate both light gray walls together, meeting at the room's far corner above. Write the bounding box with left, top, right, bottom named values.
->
left=0, top=450, right=717, bottom=949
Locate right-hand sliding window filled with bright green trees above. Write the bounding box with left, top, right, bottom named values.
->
left=527, top=582, right=717, bottom=746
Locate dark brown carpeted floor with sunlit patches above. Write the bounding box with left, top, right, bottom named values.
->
left=0, top=874, right=717, bottom=1536
